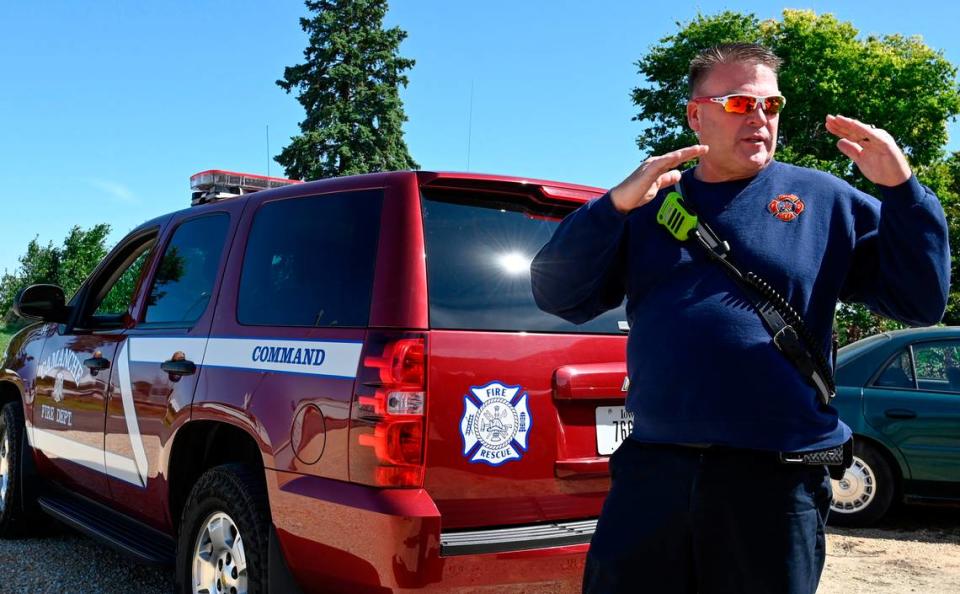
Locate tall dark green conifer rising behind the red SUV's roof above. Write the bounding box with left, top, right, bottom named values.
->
left=276, top=0, right=418, bottom=179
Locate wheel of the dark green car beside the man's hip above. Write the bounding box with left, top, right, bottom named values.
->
left=830, top=442, right=895, bottom=526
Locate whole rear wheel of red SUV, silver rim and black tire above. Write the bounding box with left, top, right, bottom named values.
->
left=177, top=464, right=270, bottom=594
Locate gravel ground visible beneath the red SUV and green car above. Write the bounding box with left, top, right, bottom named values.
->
left=0, top=506, right=960, bottom=594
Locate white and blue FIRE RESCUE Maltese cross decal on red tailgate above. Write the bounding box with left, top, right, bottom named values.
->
left=460, top=381, right=533, bottom=466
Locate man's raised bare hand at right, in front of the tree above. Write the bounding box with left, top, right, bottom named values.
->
left=827, top=115, right=913, bottom=186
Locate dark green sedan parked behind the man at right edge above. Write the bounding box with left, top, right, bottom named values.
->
left=830, top=327, right=960, bottom=526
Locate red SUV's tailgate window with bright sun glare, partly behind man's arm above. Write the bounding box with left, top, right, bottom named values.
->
left=423, top=191, right=627, bottom=334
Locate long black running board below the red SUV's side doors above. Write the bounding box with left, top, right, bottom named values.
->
left=37, top=493, right=176, bottom=565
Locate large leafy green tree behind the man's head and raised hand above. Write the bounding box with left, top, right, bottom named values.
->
left=632, top=9, right=960, bottom=342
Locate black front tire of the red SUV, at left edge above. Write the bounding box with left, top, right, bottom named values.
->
left=0, top=401, right=42, bottom=538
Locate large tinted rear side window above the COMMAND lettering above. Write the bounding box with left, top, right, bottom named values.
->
left=237, top=190, right=383, bottom=327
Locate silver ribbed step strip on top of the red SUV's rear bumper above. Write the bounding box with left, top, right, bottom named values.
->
left=440, top=520, right=597, bottom=556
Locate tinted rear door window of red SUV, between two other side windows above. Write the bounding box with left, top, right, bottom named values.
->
left=144, top=214, right=230, bottom=324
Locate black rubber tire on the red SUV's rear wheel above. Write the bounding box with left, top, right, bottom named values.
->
left=177, top=464, right=271, bottom=594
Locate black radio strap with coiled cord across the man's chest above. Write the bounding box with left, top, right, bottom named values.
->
left=674, top=183, right=837, bottom=404
